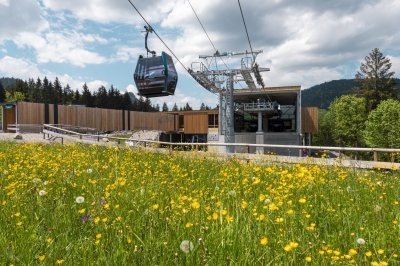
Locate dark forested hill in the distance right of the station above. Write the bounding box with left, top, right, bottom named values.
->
left=301, top=79, right=400, bottom=109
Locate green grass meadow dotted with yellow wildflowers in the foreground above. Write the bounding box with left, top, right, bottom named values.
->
left=0, top=142, right=400, bottom=265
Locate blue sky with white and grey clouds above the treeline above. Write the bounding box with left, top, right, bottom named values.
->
left=0, top=0, right=400, bottom=108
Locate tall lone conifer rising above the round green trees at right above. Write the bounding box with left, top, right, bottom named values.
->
left=356, top=48, right=397, bottom=111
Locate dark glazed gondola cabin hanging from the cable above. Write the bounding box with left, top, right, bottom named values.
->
left=133, top=52, right=178, bottom=98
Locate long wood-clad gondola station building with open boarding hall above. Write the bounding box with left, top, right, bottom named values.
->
left=0, top=97, right=318, bottom=153
